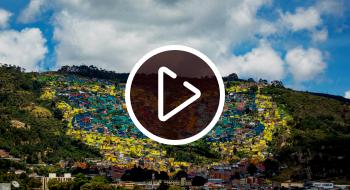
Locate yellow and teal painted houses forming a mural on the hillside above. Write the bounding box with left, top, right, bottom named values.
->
left=40, top=74, right=291, bottom=174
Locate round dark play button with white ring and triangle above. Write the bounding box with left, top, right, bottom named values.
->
left=125, top=45, right=225, bottom=145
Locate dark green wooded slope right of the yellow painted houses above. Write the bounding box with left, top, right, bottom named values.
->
left=264, top=87, right=350, bottom=181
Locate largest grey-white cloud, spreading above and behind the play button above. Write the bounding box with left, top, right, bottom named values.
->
left=50, top=0, right=275, bottom=72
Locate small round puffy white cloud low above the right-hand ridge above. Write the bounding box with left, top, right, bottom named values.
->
left=286, top=47, right=326, bottom=83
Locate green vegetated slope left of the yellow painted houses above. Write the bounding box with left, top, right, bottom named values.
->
left=0, top=65, right=99, bottom=163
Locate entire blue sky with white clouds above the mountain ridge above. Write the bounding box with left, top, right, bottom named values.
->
left=0, top=0, right=350, bottom=98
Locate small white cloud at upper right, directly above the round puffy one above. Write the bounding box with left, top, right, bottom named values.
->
left=281, top=7, right=322, bottom=31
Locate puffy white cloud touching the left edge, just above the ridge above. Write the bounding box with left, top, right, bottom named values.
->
left=0, top=28, right=47, bottom=71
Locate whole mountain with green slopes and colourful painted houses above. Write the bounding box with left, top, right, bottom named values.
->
left=0, top=66, right=350, bottom=181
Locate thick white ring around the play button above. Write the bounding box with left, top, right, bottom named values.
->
left=125, top=45, right=225, bottom=145
